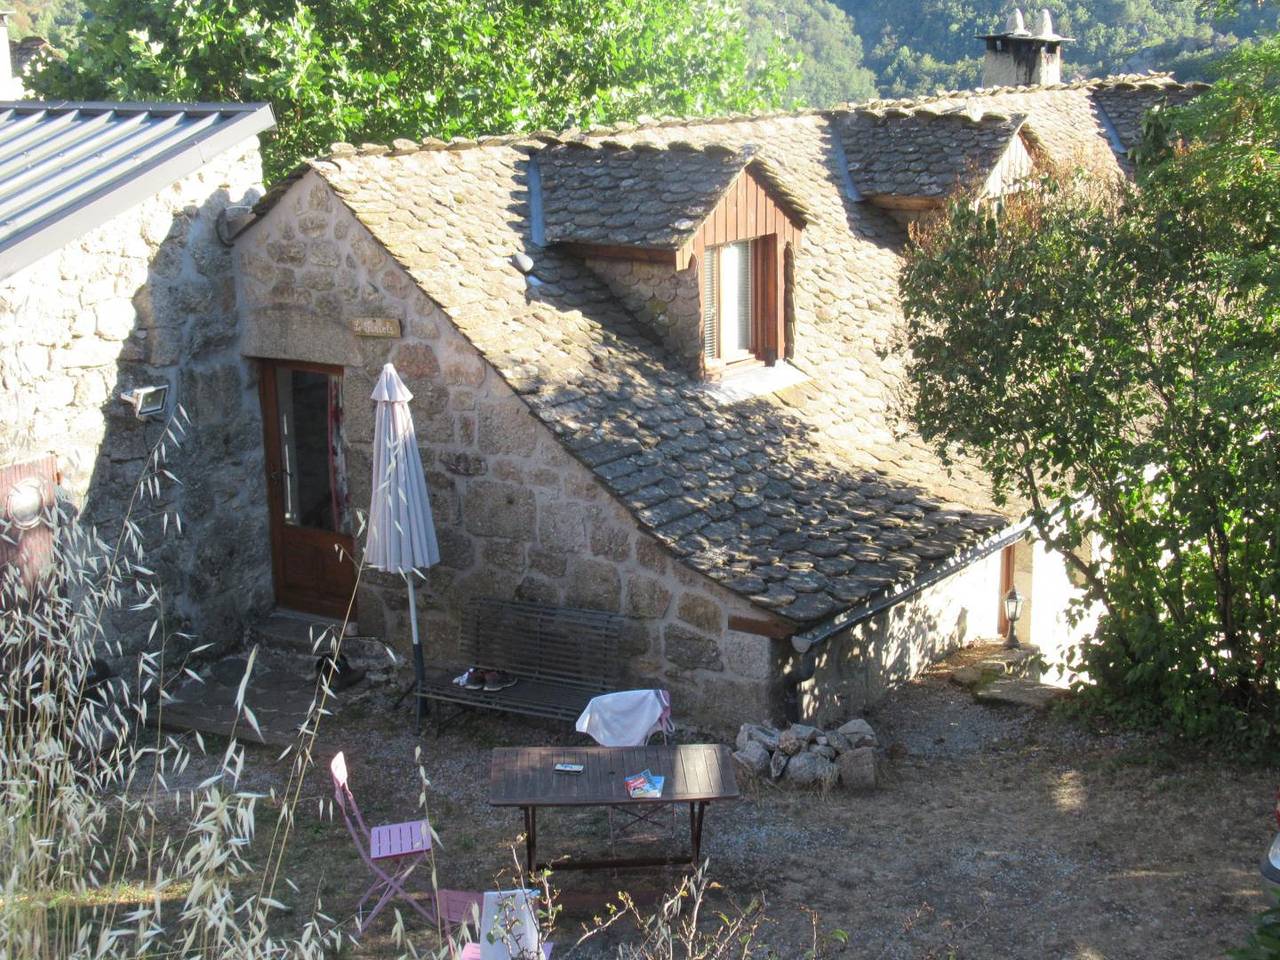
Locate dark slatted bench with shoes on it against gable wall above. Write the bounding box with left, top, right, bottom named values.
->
left=422, top=598, right=623, bottom=730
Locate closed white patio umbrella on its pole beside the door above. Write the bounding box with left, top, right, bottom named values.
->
left=365, top=364, right=440, bottom=730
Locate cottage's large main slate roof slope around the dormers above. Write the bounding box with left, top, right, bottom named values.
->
left=247, top=73, right=1198, bottom=628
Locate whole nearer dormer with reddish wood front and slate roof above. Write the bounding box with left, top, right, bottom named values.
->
left=529, top=141, right=812, bottom=381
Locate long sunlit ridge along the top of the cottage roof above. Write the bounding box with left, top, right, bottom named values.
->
left=306, top=70, right=1210, bottom=163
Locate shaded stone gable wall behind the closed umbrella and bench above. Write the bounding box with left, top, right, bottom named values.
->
left=237, top=174, right=785, bottom=732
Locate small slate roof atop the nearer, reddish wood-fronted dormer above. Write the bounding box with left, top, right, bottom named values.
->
left=538, top=141, right=806, bottom=250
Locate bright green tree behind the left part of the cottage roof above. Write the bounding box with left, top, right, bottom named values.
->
left=36, top=0, right=791, bottom=177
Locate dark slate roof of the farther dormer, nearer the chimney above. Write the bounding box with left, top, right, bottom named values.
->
left=835, top=108, right=1027, bottom=200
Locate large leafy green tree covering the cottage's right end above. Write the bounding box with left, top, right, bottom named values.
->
left=902, top=38, right=1280, bottom=745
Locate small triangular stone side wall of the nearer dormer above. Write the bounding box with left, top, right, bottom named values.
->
left=586, top=257, right=703, bottom=372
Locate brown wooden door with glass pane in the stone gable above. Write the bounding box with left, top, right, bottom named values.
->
left=260, top=361, right=356, bottom=620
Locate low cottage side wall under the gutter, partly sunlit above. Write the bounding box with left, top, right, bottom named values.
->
left=788, top=552, right=1000, bottom=726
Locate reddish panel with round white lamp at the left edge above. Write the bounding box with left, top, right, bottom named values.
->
left=0, top=456, right=58, bottom=599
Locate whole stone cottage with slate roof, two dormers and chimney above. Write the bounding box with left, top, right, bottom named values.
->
left=227, top=28, right=1193, bottom=728
